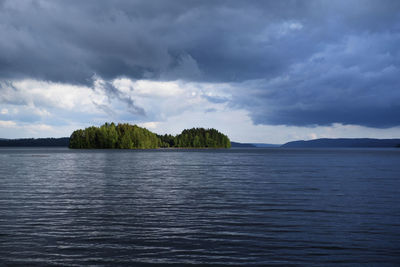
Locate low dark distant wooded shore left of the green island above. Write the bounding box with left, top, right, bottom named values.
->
left=0, top=137, right=69, bottom=147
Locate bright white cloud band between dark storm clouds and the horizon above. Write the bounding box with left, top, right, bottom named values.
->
left=0, top=78, right=400, bottom=144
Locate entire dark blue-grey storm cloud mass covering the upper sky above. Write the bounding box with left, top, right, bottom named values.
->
left=0, top=0, right=400, bottom=127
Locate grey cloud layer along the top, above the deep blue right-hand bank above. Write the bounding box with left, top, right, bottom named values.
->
left=0, top=0, right=400, bottom=84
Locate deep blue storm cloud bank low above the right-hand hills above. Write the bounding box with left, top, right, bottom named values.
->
left=230, top=30, right=400, bottom=128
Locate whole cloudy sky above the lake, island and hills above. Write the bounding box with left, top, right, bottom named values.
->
left=0, top=0, right=400, bottom=144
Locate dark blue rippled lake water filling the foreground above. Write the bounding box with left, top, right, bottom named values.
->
left=0, top=149, right=400, bottom=266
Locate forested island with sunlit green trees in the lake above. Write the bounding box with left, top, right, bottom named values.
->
left=69, top=123, right=231, bottom=149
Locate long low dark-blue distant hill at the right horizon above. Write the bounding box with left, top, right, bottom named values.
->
left=281, top=138, right=400, bottom=148
